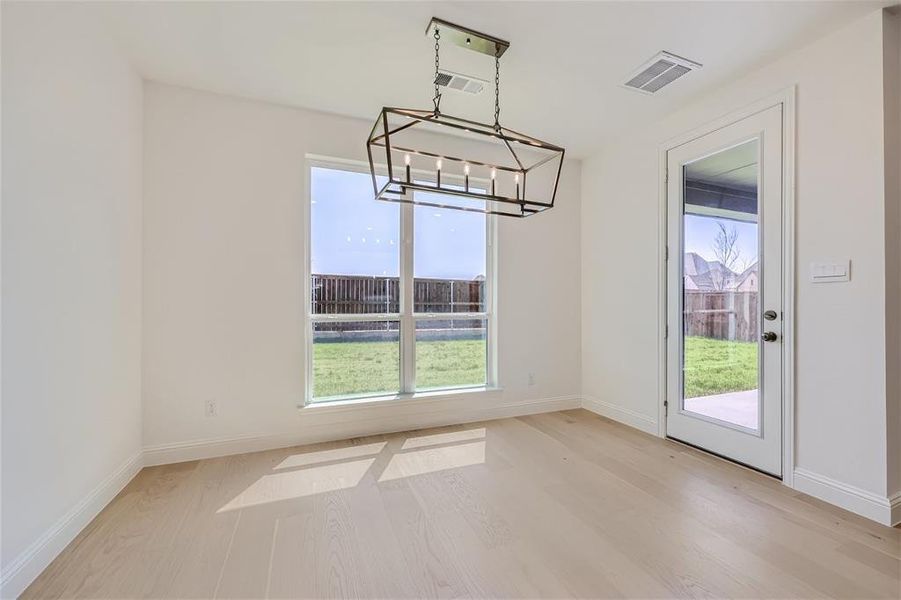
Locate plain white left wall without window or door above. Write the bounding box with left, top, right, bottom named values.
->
left=0, top=3, right=142, bottom=597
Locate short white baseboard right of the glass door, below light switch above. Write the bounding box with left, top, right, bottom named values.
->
left=794, top=467, right=901, bottom=526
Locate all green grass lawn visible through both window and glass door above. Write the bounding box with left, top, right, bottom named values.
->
left=313, top=337, right=757, bottom=398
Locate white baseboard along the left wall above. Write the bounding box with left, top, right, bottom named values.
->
left=0, top=452, right=143, bottom=598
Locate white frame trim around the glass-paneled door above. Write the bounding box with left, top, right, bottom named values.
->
left=657, top=86, right=796, bottom=487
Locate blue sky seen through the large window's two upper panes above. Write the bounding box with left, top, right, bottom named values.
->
left=310, top=168, right=485, bottom=279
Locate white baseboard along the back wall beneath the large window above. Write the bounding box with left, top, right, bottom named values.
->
left=144, top=396, right=582, bottom=466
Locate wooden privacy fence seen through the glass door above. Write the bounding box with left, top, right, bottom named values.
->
left=683, top=291, right=760, bottom=342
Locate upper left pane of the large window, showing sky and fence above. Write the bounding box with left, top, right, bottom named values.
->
left=310, top=167, right=400, bottom=314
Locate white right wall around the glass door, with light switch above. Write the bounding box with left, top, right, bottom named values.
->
left=582, top=12, right=897, bottom=516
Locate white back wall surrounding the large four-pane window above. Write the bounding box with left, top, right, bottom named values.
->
left=143, top=83, right=580, bottom=462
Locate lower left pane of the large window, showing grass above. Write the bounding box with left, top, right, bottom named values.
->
left=313, top=321, right=400, bottom=402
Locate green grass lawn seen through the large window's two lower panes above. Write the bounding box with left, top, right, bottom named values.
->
left=313, top=340, right=485, bottom=398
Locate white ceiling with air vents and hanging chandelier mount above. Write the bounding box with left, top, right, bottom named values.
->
left=85, top=0, right=892, bottom=156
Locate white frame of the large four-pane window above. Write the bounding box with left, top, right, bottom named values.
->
left=301, top=155, right=497, bottom=408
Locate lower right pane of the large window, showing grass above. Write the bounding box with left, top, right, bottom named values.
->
left=416, top=319, right=488, bottom=390
